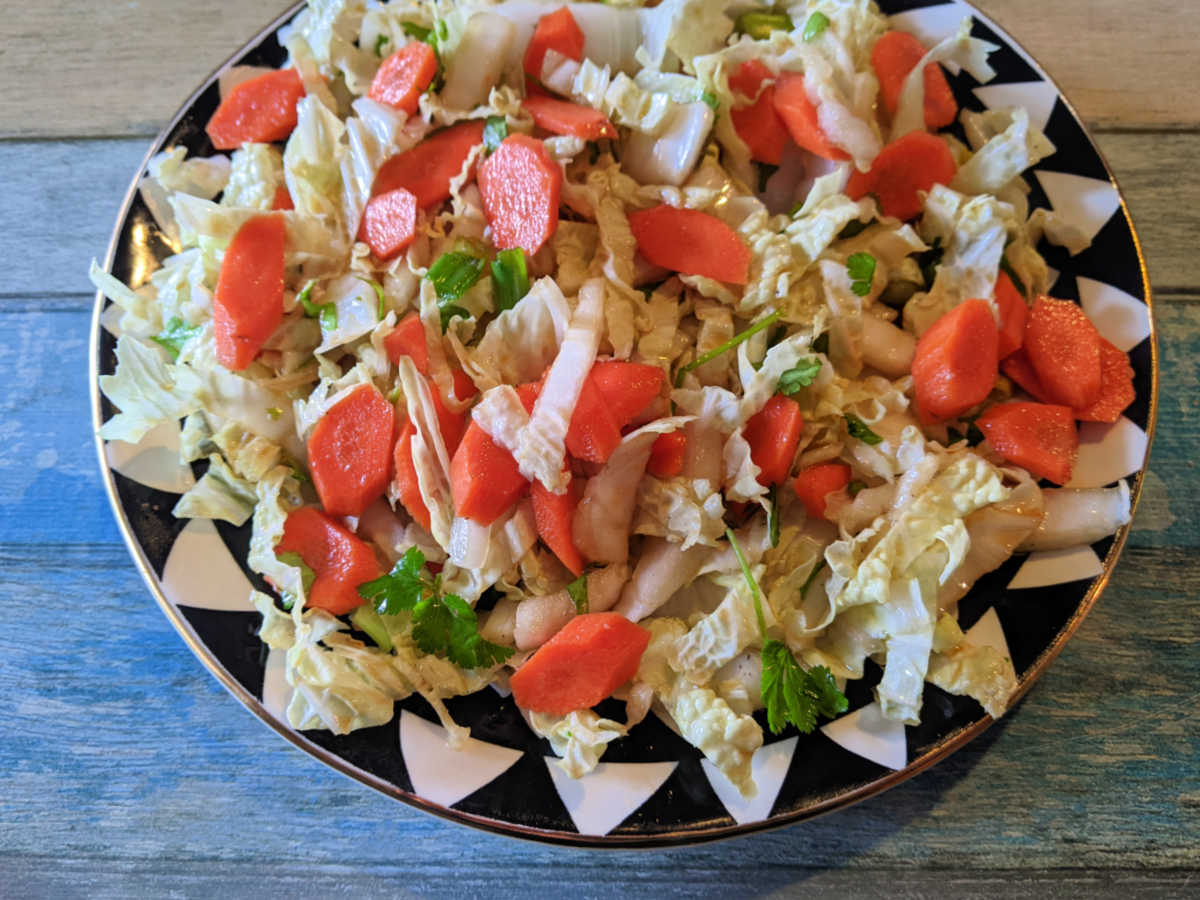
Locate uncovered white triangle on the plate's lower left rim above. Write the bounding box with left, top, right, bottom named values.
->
left=162, top=518, right=254, bottom=612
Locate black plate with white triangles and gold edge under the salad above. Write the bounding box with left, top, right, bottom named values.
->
left=90, top=0, right=1157, bottom=847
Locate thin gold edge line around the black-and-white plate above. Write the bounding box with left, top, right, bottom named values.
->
left=88, top=0, right=1159, bottom=850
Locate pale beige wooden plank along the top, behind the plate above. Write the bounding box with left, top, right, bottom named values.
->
left=0, top=0, right=1200, bottom=137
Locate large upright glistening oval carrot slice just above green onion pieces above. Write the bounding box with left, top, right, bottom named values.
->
left=479, top=134, right=563, bottom=256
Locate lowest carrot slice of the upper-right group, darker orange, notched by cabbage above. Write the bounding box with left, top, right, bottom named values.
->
left=846, top=131, right=958, bottom=220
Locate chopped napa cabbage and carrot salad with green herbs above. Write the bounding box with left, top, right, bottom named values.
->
left=91, top=0, right=1134, bottom=796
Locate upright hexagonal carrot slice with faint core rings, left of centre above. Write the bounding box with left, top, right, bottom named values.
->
left=308, top=384, right=395, bottom=516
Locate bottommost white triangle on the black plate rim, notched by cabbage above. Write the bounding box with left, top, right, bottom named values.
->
left=546, top=756, right=678, bottom=835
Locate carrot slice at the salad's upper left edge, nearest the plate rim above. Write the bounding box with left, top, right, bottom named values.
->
left=204, top=68, right=304, bottom=150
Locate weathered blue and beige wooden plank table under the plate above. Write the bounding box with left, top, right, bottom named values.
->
left=0, top=0, right=1200, bottom=896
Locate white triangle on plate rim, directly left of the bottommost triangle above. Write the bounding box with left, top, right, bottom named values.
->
left=400, top=709, right=522, bottom=806
